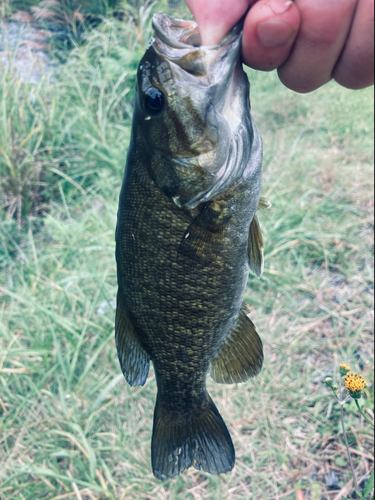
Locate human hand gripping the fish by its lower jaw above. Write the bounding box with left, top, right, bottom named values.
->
left=185, top=0, right=374, bottom=93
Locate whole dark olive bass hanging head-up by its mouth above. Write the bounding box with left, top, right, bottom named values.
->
left=115, top=14, right=269, bottom=480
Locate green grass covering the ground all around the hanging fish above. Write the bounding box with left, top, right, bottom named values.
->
left=0, top=7, right=373, bottom=500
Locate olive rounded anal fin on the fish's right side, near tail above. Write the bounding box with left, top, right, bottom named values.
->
left=210, top=310, right=263, bottom=384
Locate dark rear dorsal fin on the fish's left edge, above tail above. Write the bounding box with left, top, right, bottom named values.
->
left=115, top=295, right=150, bottom=386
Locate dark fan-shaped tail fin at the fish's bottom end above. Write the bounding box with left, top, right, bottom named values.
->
left=151, top=394, right=235, bottom=479
